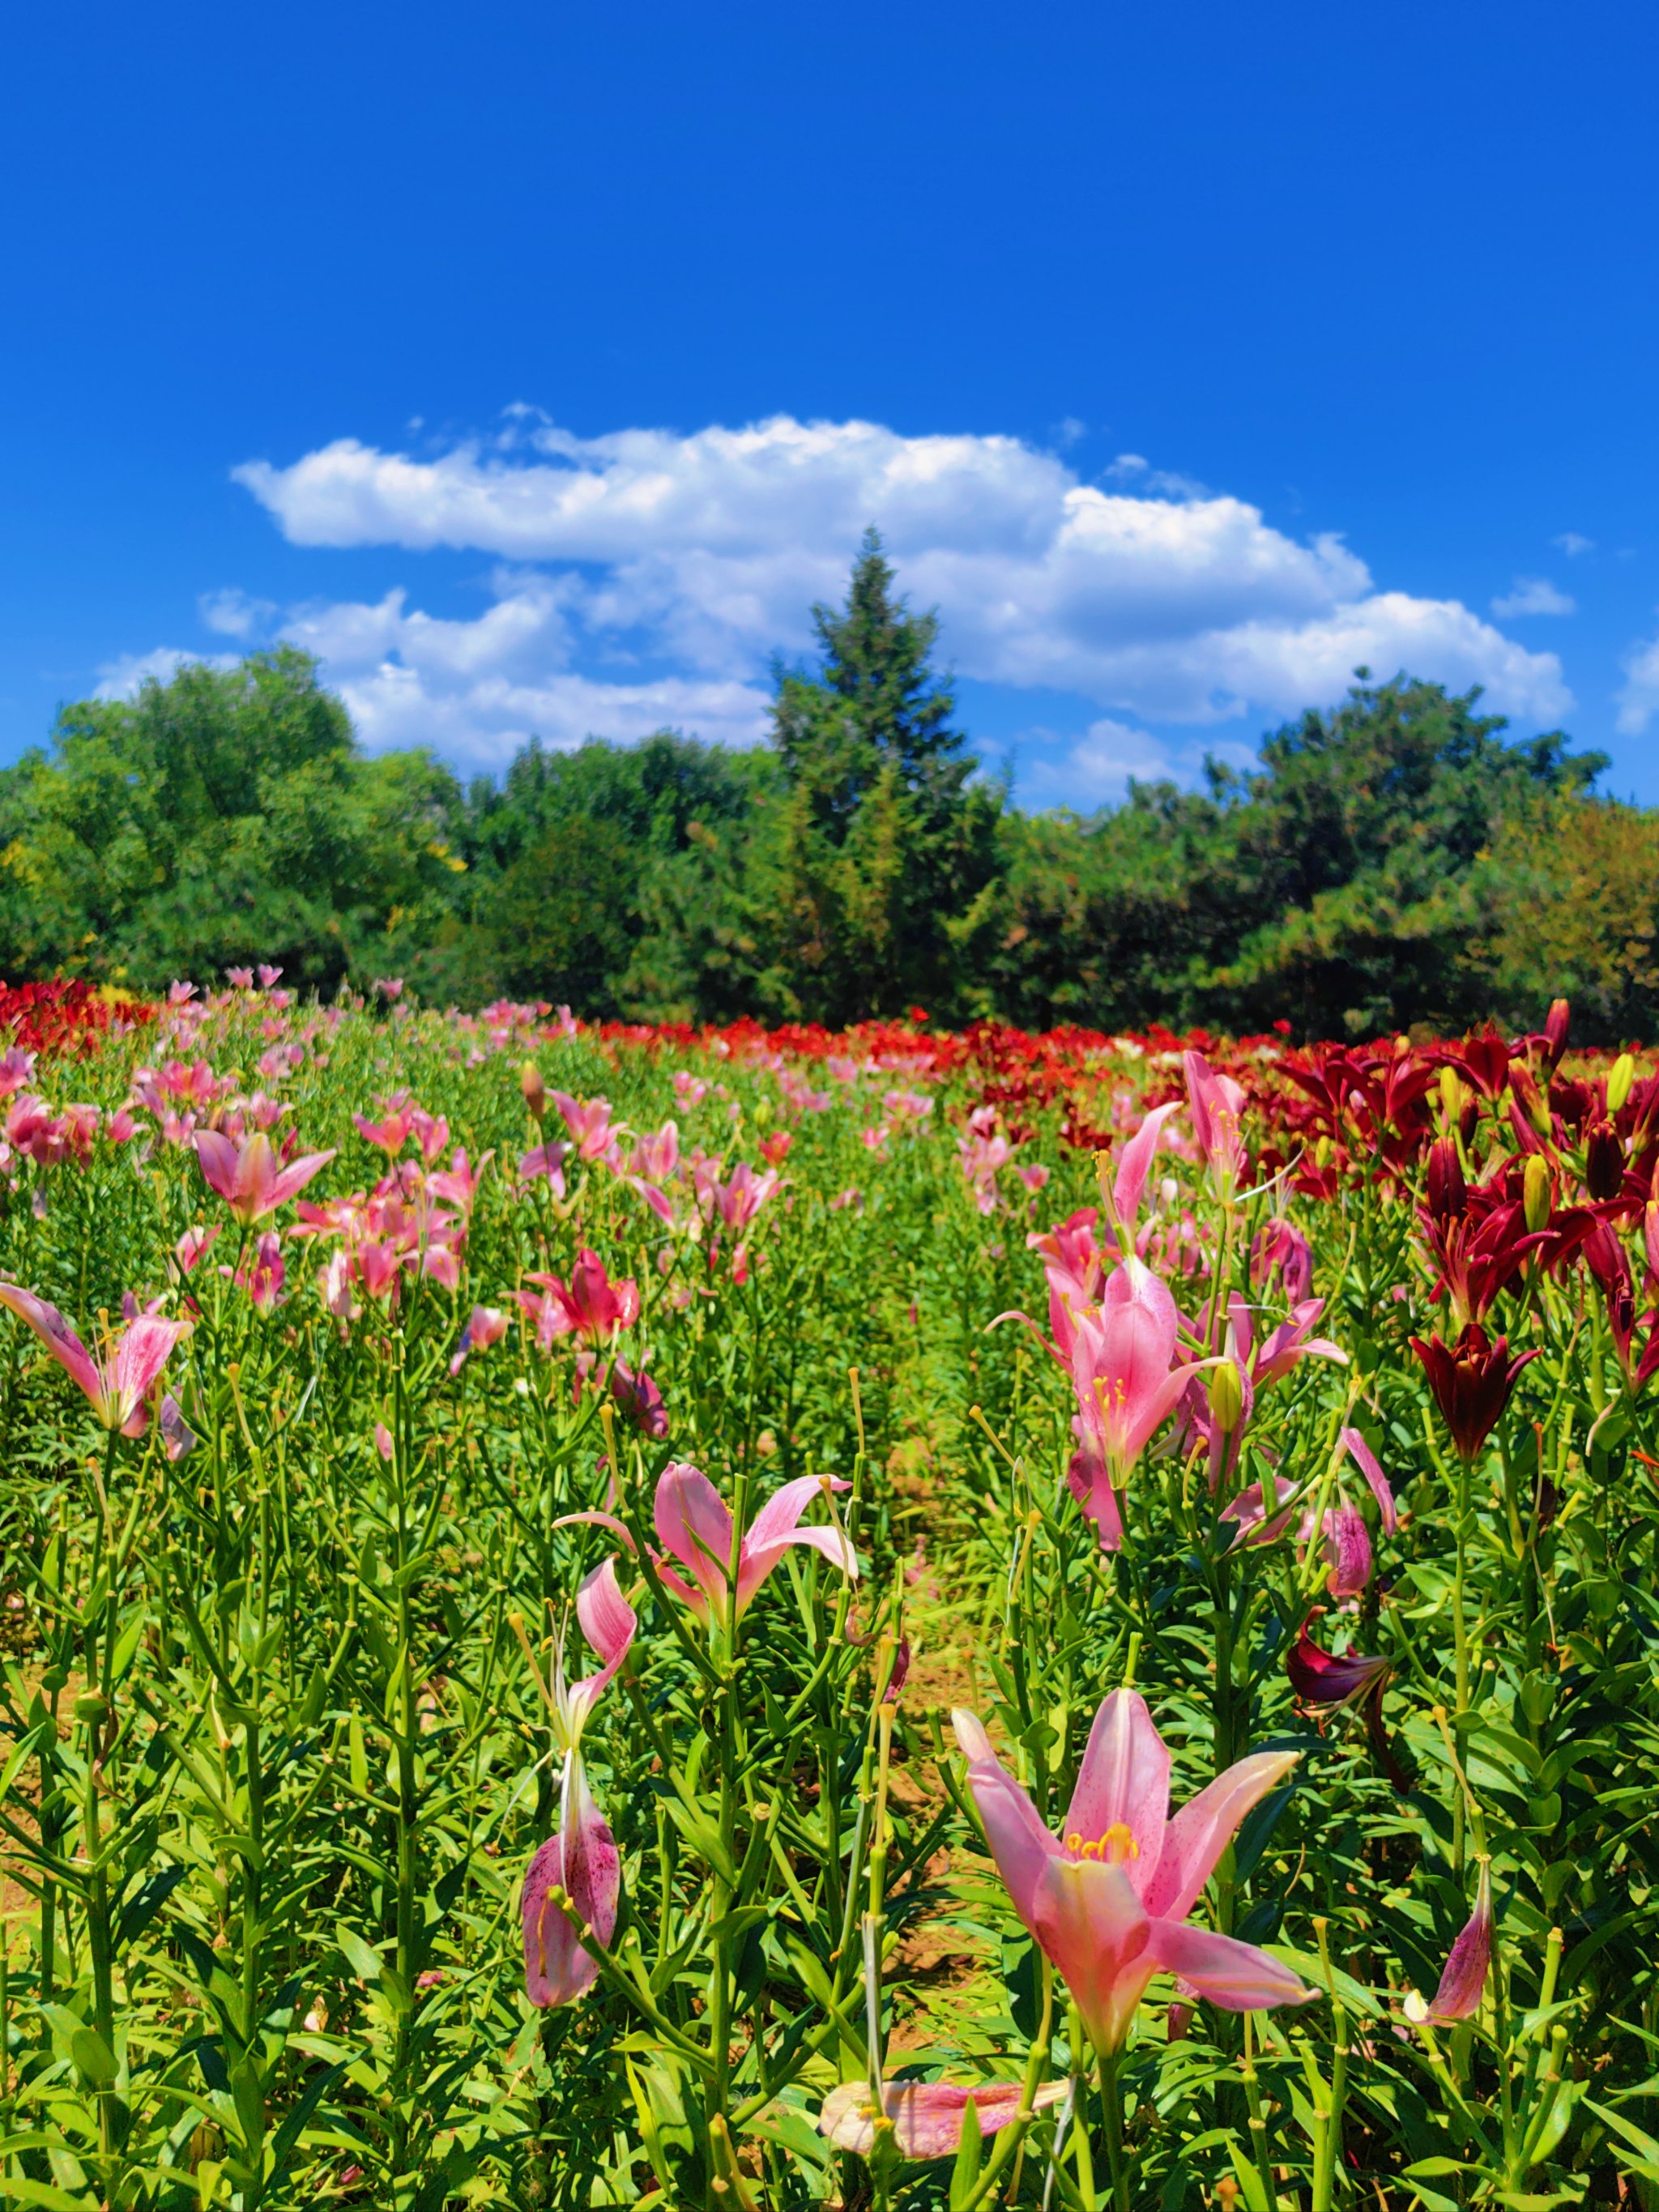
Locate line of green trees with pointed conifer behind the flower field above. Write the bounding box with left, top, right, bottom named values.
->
left=0, top=533, right=1659, bottom=1040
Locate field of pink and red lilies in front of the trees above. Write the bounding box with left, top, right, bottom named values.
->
left=0, top=995, right=1659, bottom=2212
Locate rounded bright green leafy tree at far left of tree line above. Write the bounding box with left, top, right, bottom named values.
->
left=0, top=648, right=460, bottom=987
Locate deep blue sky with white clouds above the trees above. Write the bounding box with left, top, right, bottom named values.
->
left=0, top=0, right=1659, bottom=803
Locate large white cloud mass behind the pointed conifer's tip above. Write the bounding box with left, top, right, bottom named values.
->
left=176, top=409, right=1568, bottom=757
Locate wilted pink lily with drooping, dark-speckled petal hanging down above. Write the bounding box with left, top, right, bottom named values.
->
left=520, top=1559, right=639, bottom=2009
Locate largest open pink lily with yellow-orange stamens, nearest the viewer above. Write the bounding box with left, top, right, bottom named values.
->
left=951, top=1690, right=1316, bottom=2052
